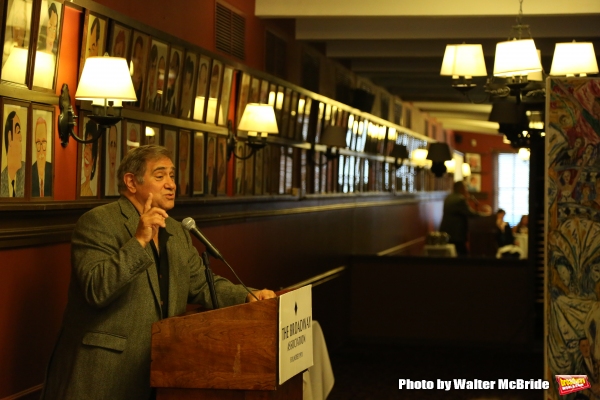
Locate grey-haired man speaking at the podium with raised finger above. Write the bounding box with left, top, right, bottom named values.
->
left=42, top=145, right=275, bottom=400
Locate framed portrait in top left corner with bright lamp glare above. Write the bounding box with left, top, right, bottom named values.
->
left=1, top=0, right=33, bottom=84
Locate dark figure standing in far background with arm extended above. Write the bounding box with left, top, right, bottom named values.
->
left=440, top=181, right=491, bottom=256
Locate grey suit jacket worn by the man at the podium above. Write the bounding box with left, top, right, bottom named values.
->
left=42, top=197, right=247, bottom=400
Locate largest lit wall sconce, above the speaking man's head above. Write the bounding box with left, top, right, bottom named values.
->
left=58, top=55, right=137, bottom=147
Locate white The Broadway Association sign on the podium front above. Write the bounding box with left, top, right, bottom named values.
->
left=279, top=285, right=313, bottom=385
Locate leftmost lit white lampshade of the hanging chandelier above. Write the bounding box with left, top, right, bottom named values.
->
left=440, top=44, right=487, bottom=77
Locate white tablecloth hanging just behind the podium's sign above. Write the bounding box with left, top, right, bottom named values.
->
left=302, top=320, right=334, bottom=400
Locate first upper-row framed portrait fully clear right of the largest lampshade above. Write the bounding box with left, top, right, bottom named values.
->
left=144, top=39, right=169, bottom=113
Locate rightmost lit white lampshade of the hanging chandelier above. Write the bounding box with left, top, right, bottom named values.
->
left=550, top=42, right=598, bottom=76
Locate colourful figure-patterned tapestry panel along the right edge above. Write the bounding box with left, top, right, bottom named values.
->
left=546, top=78, right=600, bottom=400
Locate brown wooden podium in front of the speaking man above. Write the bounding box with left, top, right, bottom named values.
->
left=150, top=297, right=303, bottom=400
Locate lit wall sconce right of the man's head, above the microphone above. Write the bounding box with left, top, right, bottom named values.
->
left=227, top=103, right=279, bottom=160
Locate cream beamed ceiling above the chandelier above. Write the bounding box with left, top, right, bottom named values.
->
left=255, top=0, right=600, bottom=134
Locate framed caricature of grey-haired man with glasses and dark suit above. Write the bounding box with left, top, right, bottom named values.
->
left=31, top=105, right=54, bottom=198
